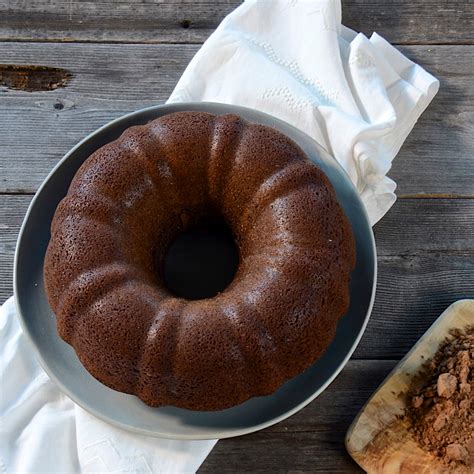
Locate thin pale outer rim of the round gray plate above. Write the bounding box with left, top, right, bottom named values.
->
left=13, top=102, right=378, bottom=440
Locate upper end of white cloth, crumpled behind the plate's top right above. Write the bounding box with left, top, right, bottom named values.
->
left=168, top=0, right=439, bottom=224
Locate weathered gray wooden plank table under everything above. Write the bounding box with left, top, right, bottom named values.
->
left=0, top=0, right=474, bottom=472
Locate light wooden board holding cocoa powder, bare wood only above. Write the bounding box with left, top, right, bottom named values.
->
left=346, top=300, right=474, bottom=474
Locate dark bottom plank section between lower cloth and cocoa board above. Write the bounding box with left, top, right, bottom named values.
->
left=198, top=361, right=396, bottom=473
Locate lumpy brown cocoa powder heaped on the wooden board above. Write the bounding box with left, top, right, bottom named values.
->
left=405, top=326, right=474, bottom=472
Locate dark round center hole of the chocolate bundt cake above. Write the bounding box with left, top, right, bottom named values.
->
left=161, top=217, right=239, bottom=300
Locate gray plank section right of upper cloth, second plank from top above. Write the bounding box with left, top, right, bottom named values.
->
left=389, top=46, right=474, bottom=196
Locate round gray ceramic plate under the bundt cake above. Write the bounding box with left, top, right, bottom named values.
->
left=14, top=103, right=376, bottom=439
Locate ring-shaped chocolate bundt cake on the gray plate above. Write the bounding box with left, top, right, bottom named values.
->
left=44, top=112, right=355, bottom=410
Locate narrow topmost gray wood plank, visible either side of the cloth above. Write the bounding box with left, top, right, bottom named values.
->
left=0, top=0, right=474, bottom=44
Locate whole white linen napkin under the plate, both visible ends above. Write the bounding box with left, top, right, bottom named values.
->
left=0, top=0, right=439, bottom=473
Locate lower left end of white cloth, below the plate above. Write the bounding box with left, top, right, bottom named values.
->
left=0, top=297, right=216, bottom=474
